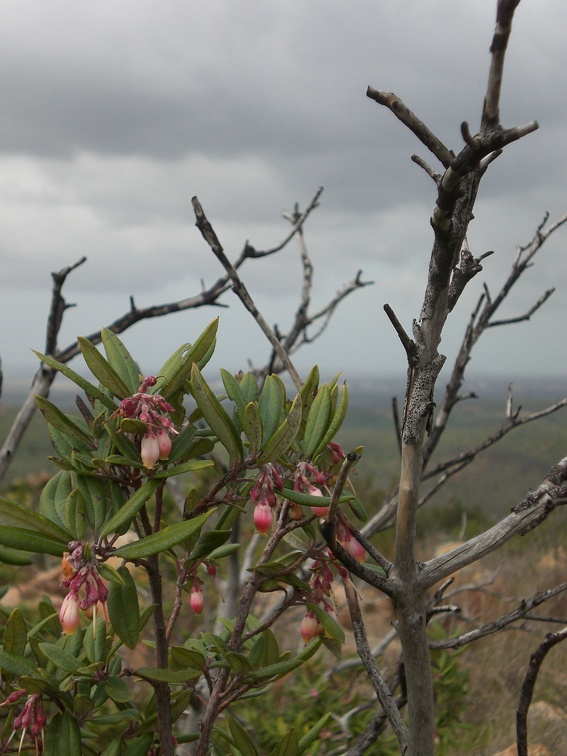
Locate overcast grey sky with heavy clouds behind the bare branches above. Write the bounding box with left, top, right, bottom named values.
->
left=0, top=0, right=567, bottom=396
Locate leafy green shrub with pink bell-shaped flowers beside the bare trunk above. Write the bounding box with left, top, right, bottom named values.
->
left=0, top=320, right=364, bottom=755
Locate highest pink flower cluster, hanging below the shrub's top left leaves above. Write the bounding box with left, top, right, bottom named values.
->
left=117, top=375, right=177, bottom=470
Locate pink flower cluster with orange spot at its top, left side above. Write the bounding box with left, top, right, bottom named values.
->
left=59, top=541, right=109, bottom=635
